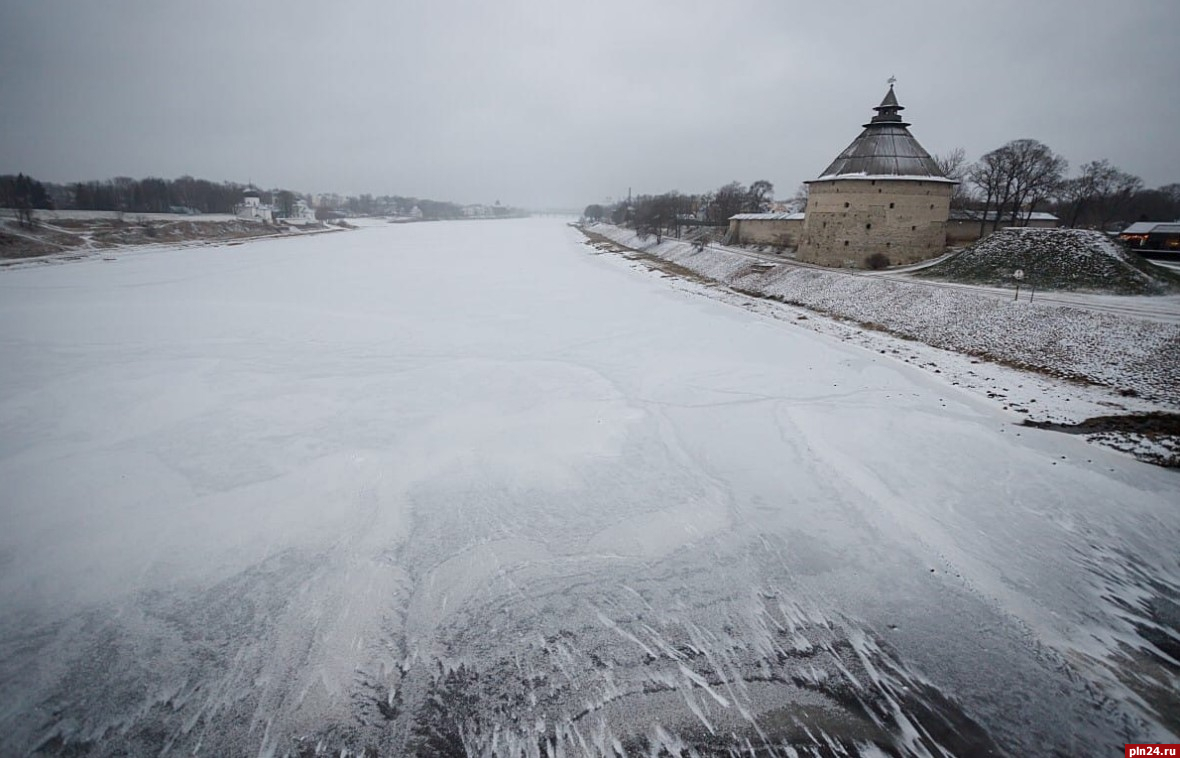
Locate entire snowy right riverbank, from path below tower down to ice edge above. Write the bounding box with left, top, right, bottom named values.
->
left=584, top=224, right=1180, bottom=466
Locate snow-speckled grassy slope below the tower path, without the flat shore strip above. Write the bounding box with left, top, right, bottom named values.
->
left=594, top=226, right=1180, bottom=407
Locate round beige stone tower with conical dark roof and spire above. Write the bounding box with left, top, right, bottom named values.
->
left=799, top=84, right=957, bottom=268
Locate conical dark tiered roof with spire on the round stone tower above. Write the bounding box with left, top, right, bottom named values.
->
left=819, top=84, right=952, bottom=182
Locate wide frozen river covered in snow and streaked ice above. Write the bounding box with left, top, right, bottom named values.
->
left=0, top=214, right=1180, bottom=757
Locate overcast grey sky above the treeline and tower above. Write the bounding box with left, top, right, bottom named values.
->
left=0, top=0, right=1180, bottom=207
